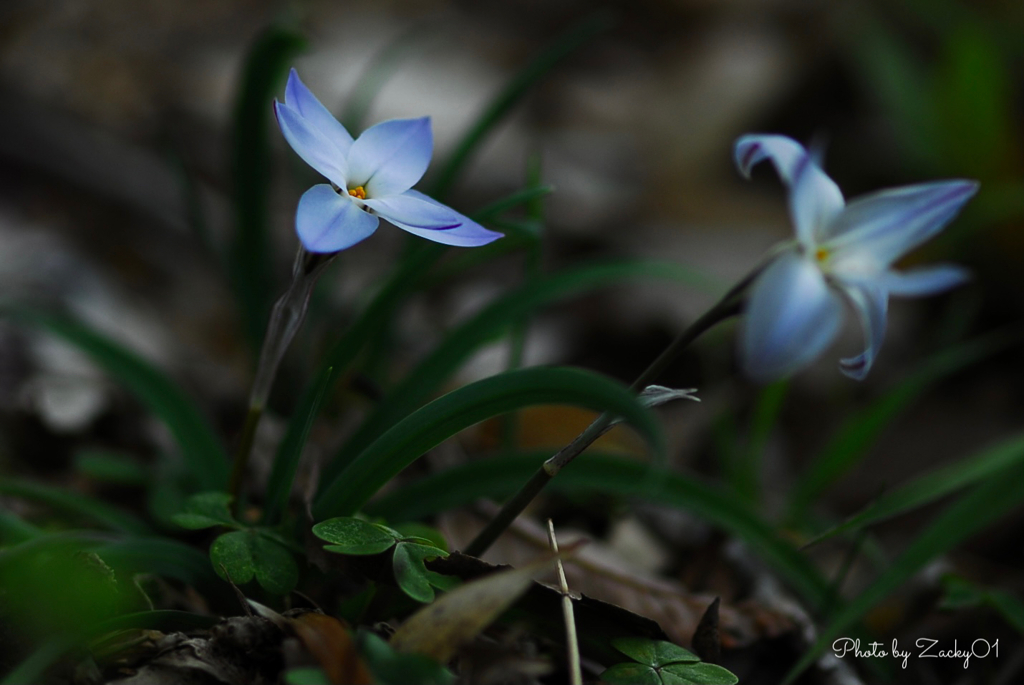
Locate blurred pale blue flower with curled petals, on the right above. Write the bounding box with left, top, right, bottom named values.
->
left=735, top=134, right=978, bottom=381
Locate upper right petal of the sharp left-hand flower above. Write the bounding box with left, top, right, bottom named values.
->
left=348, top=117, right=434, bottom=199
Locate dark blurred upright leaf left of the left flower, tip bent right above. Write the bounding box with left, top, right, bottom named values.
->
left=228, top=27, right=305, bottom=349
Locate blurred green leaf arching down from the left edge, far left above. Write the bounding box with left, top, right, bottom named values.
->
left=6, top=308, right=227, bottom=489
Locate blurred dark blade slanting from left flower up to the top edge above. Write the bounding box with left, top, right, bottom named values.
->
left=431, top=12, right=611, bottom=199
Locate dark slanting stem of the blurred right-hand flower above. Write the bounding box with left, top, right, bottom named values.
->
left=464, top=264, right=764, bottom=557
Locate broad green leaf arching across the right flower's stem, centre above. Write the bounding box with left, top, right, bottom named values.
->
left=313, top=368, right=665, bottom=518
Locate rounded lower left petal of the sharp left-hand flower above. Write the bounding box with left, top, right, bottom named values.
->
left=295, top=183, right=380, bottom=252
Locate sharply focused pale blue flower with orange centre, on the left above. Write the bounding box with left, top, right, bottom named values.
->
left=273, top=69, right=502, bottom=252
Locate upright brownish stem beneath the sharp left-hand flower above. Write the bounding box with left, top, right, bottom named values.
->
left=228, top=246, right=337, bottom=514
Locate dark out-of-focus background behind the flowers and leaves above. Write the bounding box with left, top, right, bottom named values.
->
left=0, top=0, right=1024, bottom=679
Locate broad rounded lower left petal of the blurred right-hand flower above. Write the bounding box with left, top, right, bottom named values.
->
left=739, top=252, right=843, bottom=381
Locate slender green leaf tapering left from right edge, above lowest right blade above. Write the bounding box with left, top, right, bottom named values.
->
left=804, top=435, right=1024, bottom=548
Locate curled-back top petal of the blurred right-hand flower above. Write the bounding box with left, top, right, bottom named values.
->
left=735, top=134, right=844, bottom=247
